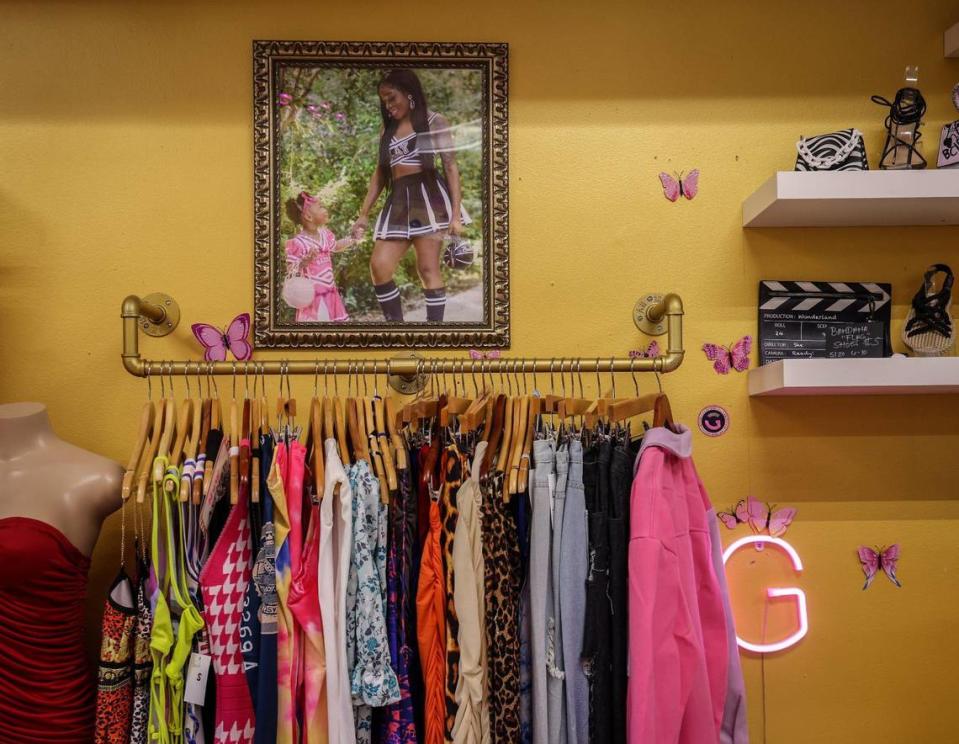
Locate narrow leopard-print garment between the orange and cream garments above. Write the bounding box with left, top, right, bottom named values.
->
left=440, top=444, right=465, bottom=741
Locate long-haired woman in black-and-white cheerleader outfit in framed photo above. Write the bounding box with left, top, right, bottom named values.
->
left=353, top=69, right=470, bottom=322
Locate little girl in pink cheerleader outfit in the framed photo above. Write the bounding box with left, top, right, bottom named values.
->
left=285, top=191, right=355, bottom=323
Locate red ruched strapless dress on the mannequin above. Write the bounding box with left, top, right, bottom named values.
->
left=0, top=517, right=96, bottom=744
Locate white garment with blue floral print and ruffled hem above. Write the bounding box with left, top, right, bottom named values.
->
left=346, top=460, right=400, bottom=744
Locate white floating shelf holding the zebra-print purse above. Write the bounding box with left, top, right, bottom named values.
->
left=743, top=169, right=959, bottom=227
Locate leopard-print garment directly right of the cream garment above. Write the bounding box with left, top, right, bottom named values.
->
left=481, top=473, right=522, bottom=744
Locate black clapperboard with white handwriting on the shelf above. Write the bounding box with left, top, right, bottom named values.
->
left=759, top=280, right=892, bottom=364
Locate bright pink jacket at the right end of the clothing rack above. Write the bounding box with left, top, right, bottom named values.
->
left=626, top=427, right=728, bottom=744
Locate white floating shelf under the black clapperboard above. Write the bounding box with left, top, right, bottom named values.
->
left=749, top=357, right=959, bottom=396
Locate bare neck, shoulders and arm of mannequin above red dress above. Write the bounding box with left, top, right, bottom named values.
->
left=0, top=403, right=123, bottom=556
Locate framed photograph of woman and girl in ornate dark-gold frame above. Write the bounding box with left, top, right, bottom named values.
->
left=253, top=41, right=510, bottom=348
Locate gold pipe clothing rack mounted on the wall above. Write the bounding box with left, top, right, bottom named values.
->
left=120, top=293, right=685, bottom=393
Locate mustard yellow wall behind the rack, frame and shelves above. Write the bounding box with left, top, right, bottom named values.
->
left=0, top=0, right=959, bottom=744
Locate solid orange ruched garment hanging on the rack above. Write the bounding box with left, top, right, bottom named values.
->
left=416, top=500, right=446, bottom=744
